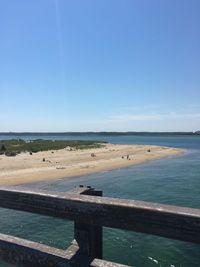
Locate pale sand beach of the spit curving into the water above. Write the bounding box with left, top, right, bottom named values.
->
left=0, top=144, right=183, bottom=185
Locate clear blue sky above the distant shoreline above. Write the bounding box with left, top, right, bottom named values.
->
left=0, top=0, right=200, bottom=131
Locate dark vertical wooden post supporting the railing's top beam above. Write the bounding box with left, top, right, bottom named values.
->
left=74, top=188, right=103, bottom=259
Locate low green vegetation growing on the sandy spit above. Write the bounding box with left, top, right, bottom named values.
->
left=0, top=139, right=105, bottom=156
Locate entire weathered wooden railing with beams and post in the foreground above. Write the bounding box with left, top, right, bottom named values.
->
left=0, top=186, right=200, bottom=267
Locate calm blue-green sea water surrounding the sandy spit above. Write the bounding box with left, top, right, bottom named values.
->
left=0, top=134, right=200, bottom=267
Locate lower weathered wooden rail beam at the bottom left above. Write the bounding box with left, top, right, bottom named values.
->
left=0, top=234, right=128, bottom=267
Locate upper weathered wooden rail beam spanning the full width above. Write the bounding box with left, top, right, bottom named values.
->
left=0, top=187, right=200, bottom=243
